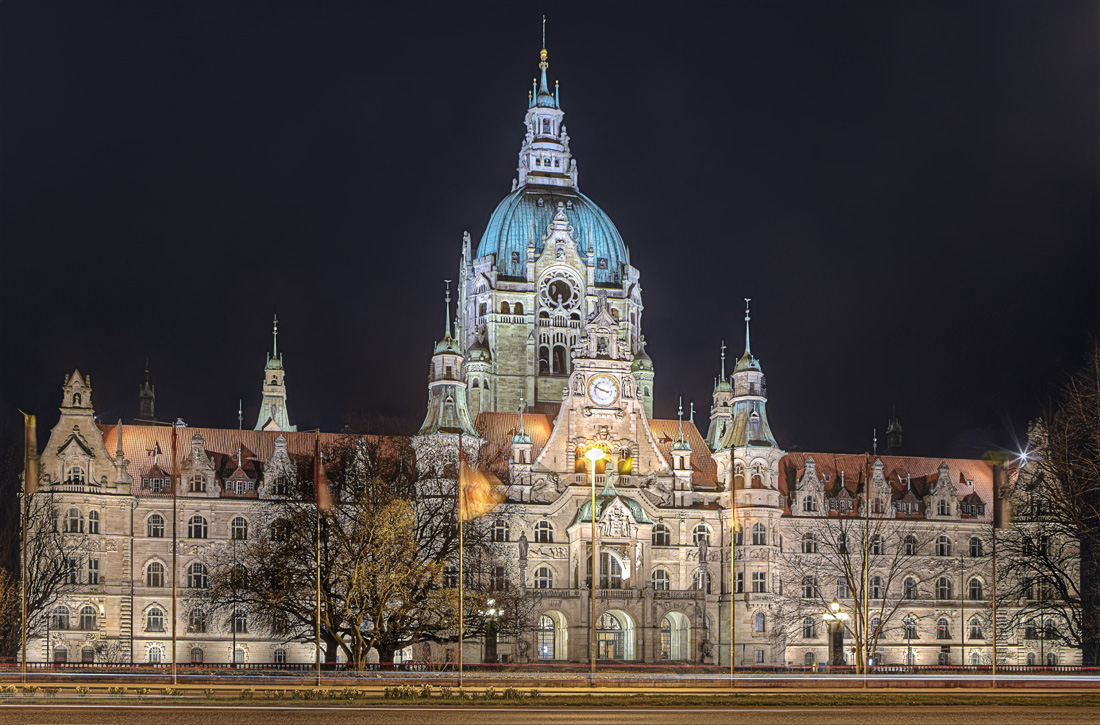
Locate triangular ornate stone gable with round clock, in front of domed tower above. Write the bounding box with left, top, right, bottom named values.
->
left=535, top=290, right=672, bottom=475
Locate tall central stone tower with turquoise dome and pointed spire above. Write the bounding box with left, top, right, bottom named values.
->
left=455, top=31, right=652, bottom=413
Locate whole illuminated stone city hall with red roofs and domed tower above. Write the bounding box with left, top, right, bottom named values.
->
left=29, top=44, right=1079, bottom=666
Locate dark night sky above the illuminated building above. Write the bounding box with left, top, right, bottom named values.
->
left=0, top=0, right=1100, bottom=455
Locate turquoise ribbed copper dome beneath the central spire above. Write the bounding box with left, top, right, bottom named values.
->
left=477, top=184, right=627, bottom=285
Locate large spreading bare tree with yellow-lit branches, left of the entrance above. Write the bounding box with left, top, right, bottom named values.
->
left=196, top=435, right=506, bottom=666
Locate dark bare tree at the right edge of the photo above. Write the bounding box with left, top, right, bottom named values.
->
left=998, top=347, right=1100, bottom=667
